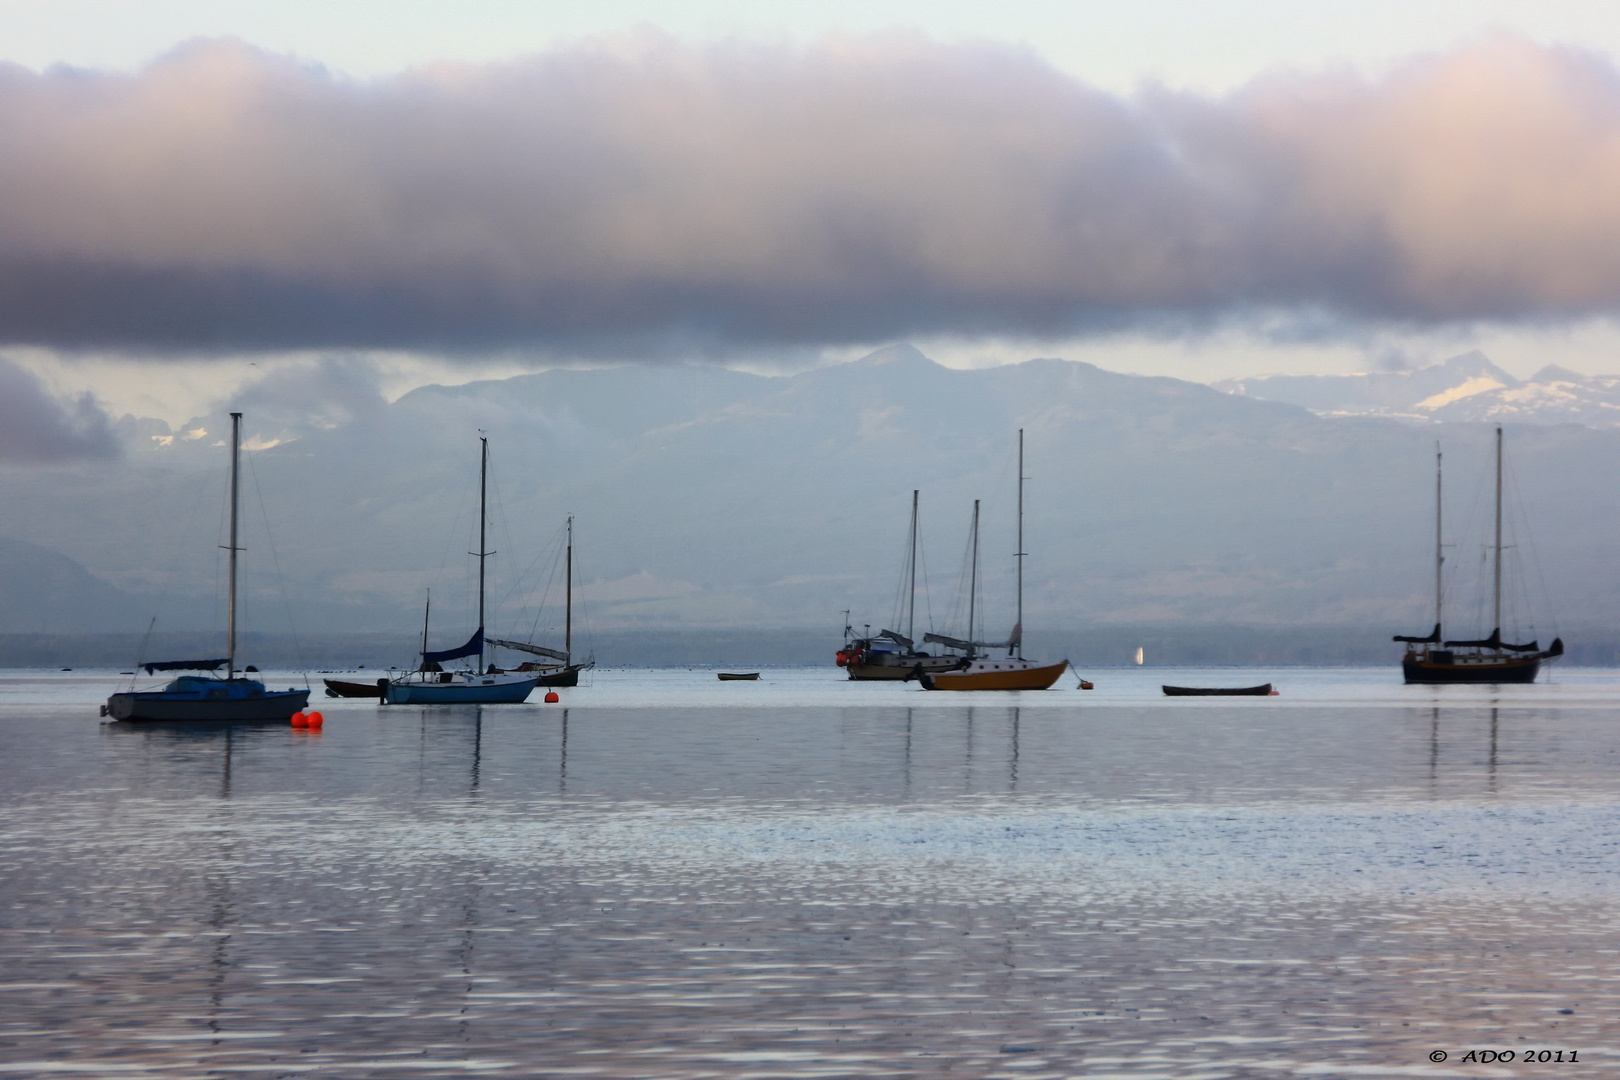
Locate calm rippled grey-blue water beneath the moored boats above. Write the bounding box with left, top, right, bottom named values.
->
left=0, top=669, right=1620, bottom=1078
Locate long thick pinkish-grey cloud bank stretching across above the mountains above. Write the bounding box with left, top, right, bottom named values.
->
left=0, top=34, right=1620, bottom=355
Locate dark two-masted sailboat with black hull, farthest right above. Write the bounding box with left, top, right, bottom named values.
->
left=1395, top=427, right=1563, bottom=683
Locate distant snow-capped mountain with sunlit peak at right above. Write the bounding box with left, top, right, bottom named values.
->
left=1213, top=351, right=1620, bottom=427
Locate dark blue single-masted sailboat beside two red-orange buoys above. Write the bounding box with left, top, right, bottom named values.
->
left=100, top=413, right=309, bottom=724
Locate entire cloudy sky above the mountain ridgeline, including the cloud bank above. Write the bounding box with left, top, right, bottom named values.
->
left=0, top=0, right=1620, bottom=420
